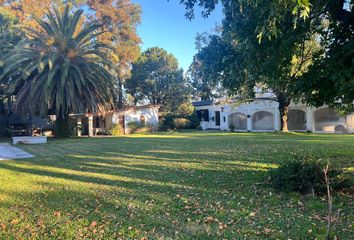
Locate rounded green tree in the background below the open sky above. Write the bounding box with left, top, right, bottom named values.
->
left=127, top=47, right=190, bottom=112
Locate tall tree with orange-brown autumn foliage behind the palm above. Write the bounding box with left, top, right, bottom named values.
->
left=0, top=0, right=141, bottom=107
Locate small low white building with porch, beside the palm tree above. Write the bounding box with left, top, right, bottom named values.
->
left=76, top=105, right=159, bottom=136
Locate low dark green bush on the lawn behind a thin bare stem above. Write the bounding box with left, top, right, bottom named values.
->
left=270, top=158, right=348, bottom=194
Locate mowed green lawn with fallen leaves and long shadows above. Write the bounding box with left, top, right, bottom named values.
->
left=0, top=132, right=354, bottom=239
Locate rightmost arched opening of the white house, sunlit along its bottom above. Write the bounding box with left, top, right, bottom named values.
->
left=314, top=108, right=346, bottom=132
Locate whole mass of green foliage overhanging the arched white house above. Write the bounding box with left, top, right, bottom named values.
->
left=182, top=0, right=354, bottom=116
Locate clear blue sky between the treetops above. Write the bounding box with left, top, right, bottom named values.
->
left=132, top=0, right=222, bottom=70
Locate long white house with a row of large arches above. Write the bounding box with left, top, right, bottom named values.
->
left=193, top=98, right=354, bottom=133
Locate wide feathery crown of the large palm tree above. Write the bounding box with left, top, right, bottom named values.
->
left=0, top=6, right=114, bottom=136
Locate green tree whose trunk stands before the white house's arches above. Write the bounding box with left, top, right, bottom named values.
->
left=191, top=1, right=318, bottom=131
